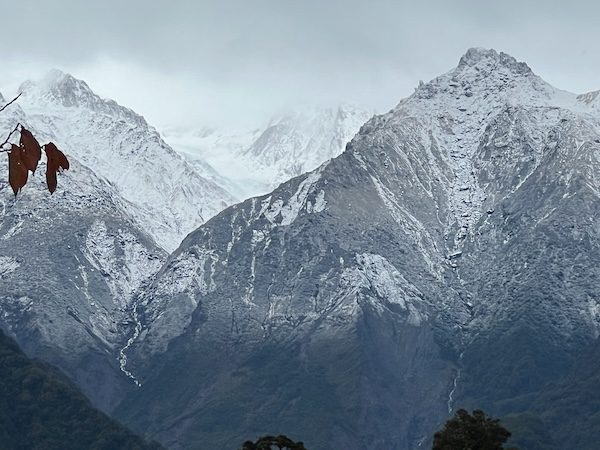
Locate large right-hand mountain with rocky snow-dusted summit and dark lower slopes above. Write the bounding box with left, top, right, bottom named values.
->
left=117, top=49, right=600, bottom=450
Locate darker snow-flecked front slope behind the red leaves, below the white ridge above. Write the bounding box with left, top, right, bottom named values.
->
left=0, top=98, right=167, bottom=410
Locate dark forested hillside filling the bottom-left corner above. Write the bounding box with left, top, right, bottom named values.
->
left=0, top=330, right=163, bottom=450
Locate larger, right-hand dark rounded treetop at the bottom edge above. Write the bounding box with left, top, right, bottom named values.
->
left=432, top=409, right=516, bottom=450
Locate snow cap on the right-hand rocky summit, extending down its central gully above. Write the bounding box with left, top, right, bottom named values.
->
left=354, top=48, right=597, bottom=255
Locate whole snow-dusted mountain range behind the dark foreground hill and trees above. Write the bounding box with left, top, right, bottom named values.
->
left=0, top=49, right=600, bottom=450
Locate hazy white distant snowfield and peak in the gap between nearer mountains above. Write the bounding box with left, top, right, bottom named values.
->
left=164, top=104, right=372, bottom=198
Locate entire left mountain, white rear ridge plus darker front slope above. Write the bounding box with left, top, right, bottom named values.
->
left=0, top=71, right=372, bottom=418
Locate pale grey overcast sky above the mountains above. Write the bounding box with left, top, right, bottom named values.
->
left=0, top=0, right=600, bottom=127
